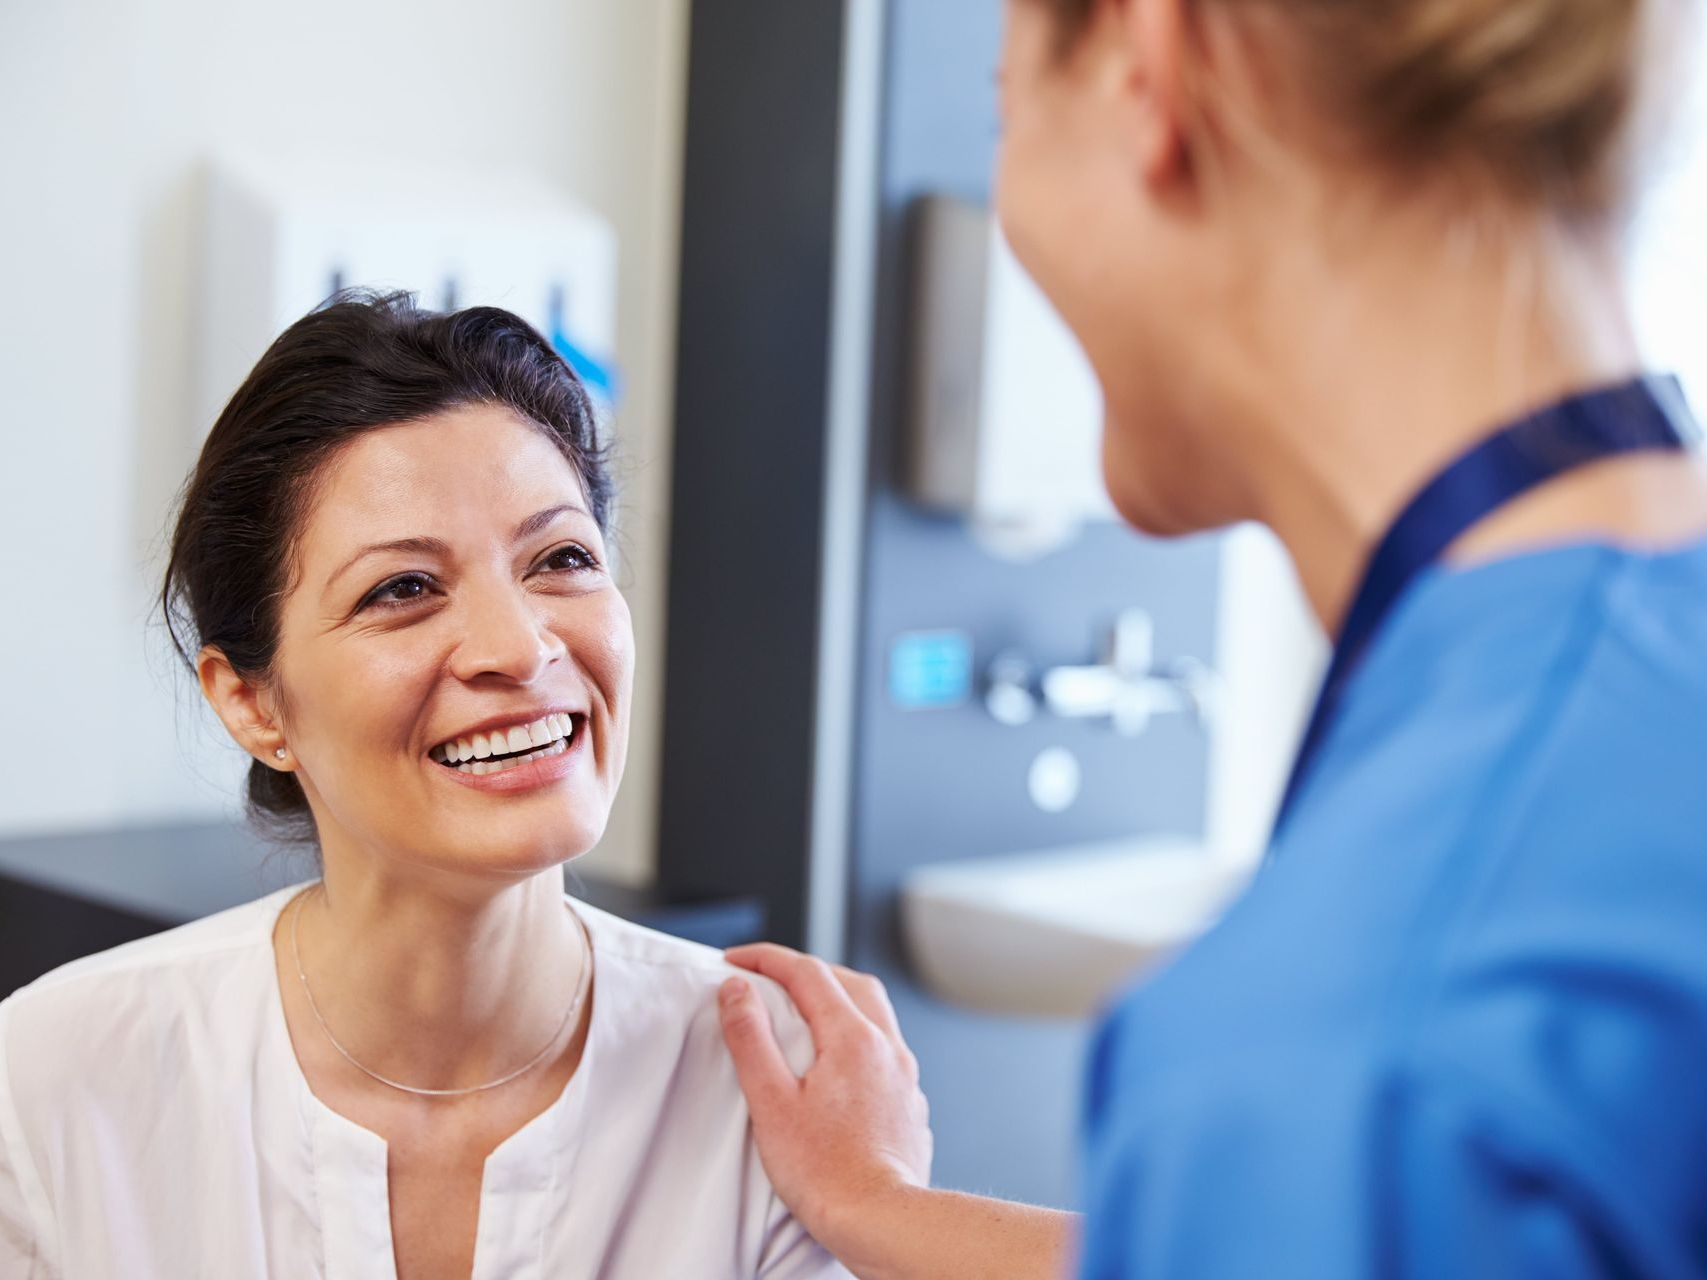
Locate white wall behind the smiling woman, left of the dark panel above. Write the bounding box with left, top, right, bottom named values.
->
left=0, top=0, right=688, bottom=881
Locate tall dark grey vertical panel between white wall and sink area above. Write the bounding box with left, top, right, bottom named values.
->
left=659, top=0, right=842, bottom=944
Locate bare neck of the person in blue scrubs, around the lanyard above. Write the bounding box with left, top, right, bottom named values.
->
left=1224, top=209, right=1707, bottom=635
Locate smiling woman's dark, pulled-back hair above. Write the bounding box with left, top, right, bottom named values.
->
left=160, top=292, right=611, bottom=845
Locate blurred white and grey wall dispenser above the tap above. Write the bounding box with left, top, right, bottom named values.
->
left=900, top=196, right=1115, bottom=556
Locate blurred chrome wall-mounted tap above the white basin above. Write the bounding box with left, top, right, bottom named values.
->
left=983, top=609, right=1215, bottom=737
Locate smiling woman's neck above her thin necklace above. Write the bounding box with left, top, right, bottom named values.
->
left=283, top=857, right=591, bottom=1089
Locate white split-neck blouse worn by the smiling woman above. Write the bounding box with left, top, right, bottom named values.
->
left=0, top=886, right=847, bottom=1280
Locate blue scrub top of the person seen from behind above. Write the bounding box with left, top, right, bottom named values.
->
left=1082, top=543, right=1707, bottom=1280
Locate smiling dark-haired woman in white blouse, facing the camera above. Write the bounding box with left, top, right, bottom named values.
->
left=0, top=295, right=843, bottom=1280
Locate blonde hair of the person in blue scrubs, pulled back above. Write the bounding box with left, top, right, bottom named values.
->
left=1041, top=0, right=1666, bottom=218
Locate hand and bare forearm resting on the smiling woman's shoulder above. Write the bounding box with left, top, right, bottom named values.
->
left=719, top=942, right=1077, bottom=1280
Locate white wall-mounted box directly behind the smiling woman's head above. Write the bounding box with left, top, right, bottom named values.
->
left=196, top=155, right=620, bottom=447
